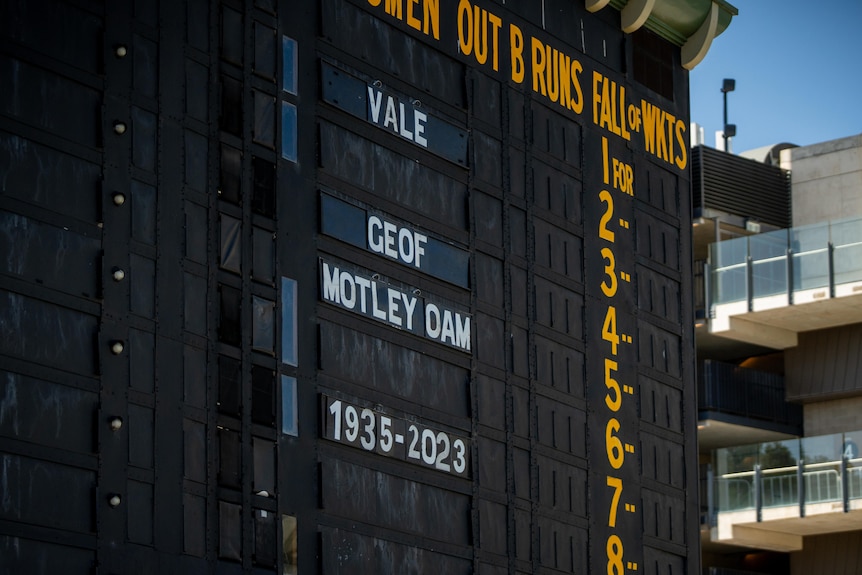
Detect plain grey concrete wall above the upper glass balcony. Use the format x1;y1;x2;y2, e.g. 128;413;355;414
781;134;862;227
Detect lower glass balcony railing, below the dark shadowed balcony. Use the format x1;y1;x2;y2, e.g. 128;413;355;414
709;431;862;518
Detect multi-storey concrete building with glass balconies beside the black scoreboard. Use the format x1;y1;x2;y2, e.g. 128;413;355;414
693;135;862;575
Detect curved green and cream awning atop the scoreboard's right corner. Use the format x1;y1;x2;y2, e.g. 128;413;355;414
584;0;739;70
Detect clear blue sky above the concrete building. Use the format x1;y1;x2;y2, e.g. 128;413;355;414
689;0;862;153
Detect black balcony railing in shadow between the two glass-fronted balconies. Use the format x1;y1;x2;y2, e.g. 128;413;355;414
697;360;802;435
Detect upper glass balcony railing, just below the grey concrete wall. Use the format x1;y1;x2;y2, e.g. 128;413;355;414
708;218;862;317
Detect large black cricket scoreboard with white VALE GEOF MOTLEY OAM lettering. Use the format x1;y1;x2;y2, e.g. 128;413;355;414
0;0;699;575
